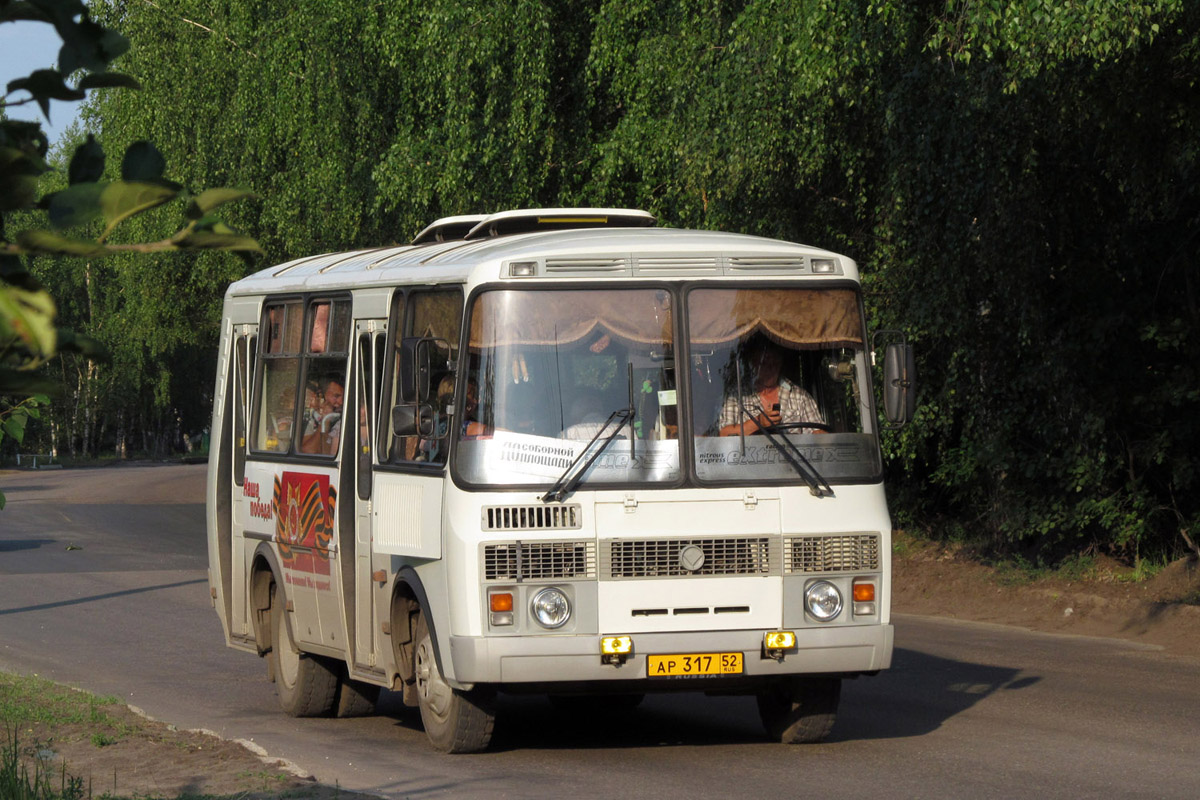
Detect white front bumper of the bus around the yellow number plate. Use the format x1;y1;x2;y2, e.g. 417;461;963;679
443;625;893;685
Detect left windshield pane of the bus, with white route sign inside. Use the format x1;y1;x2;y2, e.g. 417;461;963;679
457;289;680;486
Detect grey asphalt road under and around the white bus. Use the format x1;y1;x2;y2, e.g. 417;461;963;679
0;465;1200;799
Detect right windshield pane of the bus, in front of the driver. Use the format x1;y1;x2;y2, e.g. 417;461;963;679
688;288;881;482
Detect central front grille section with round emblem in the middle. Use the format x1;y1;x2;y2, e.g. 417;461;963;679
604;536;772;578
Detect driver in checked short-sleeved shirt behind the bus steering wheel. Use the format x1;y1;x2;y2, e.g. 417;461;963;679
718;339;824;437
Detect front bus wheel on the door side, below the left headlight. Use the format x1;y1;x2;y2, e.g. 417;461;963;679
413;613;496;753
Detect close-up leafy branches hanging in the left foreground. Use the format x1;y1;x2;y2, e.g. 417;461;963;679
0;0;258;506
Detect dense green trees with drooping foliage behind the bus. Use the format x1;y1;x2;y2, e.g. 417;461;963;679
9;0;1200;558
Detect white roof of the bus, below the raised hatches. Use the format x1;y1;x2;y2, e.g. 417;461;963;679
228;210;858;295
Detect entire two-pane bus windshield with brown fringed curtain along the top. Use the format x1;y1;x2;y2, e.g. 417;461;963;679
456;285;881;488
